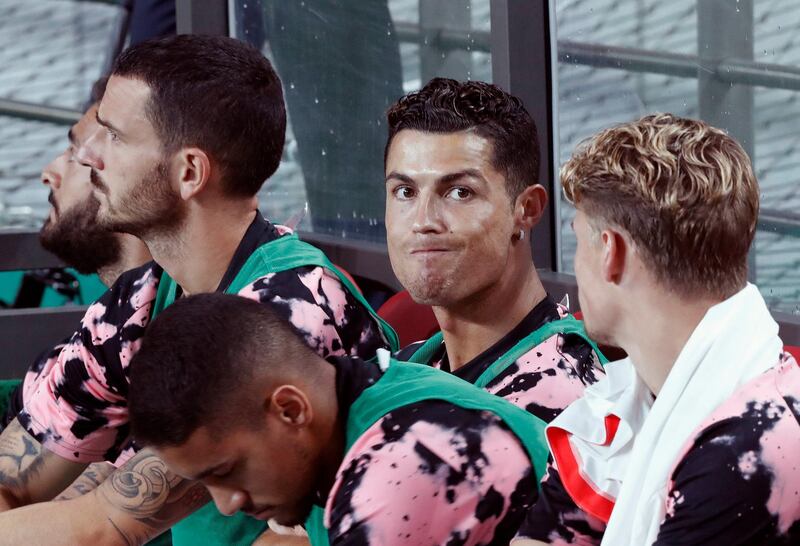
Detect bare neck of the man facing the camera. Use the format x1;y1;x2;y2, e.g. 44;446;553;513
433;261;547;371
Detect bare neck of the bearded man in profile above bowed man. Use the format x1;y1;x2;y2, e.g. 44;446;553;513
145;200;257;295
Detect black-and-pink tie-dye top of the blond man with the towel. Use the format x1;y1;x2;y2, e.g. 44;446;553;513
519;354;800;546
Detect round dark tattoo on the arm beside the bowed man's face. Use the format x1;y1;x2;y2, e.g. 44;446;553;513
97;450;210;544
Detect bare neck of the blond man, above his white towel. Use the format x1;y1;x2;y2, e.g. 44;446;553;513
618;287;720;396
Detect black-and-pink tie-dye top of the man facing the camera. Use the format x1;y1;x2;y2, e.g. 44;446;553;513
397;296;603;423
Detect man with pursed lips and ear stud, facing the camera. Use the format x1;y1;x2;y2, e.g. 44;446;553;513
385;78;602;422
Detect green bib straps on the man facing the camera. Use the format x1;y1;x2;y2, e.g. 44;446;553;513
409;315;608;387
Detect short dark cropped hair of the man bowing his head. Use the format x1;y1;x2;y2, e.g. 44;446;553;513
128;293;318;446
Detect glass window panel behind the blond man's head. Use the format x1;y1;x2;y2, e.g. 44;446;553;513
554;0;800;313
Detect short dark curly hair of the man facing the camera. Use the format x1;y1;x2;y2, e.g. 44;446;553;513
383;78;539;198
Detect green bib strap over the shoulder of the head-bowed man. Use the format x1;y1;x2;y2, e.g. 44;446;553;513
306;360;548;546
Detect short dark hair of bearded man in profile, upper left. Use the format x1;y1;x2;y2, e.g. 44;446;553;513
112;34;286;197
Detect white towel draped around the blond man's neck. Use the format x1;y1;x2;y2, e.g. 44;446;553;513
550;284;782;546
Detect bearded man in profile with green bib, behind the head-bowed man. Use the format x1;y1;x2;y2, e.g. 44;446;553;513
0;35;396;544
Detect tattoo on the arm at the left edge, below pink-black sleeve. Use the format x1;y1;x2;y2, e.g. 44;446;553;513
0;419;55;501
